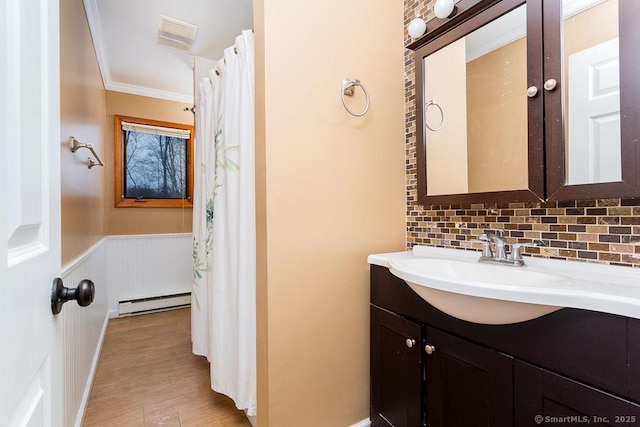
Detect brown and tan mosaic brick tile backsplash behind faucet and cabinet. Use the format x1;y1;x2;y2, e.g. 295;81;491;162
404;0;640;268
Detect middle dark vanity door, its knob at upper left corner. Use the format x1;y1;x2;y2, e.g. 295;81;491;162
423;327;519;427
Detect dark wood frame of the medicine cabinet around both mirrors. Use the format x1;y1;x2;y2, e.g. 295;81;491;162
407;0;640;205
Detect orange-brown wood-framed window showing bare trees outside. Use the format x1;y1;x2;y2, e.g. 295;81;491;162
114;116;193;208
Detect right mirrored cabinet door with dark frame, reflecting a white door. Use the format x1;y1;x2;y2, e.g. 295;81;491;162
544;0;640;200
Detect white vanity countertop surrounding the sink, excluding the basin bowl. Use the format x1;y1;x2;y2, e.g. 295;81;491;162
367;246;640;319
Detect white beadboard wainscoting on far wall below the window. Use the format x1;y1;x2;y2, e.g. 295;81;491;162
107;233;193;317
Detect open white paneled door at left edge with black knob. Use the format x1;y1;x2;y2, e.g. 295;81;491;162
0;0;62;427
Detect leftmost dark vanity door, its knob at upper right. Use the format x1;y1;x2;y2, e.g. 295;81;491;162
371;306;424;427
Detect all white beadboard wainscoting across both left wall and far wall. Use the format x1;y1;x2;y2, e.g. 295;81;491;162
61;234;192;426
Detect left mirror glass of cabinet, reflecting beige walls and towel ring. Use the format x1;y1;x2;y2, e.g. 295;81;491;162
423;5;529;196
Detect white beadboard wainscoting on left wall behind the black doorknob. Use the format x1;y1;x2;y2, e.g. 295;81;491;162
57;238;109;426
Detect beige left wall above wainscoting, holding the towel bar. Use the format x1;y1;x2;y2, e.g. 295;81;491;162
60;0;105;265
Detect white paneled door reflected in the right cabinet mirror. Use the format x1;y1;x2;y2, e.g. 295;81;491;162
567;38;622;184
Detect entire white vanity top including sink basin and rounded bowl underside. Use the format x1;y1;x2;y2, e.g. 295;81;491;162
368;246;640;324
